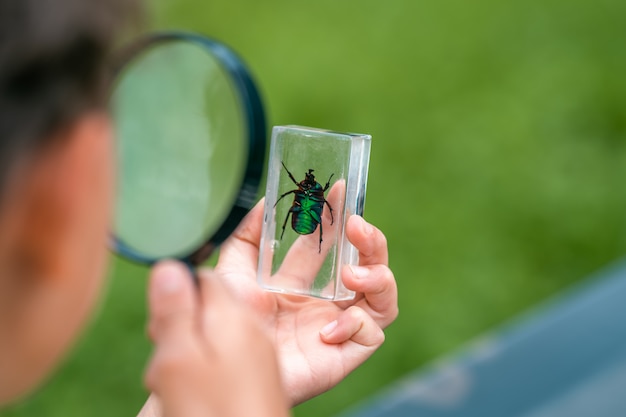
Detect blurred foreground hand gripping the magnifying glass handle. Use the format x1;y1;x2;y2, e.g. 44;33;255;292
142;261;289;417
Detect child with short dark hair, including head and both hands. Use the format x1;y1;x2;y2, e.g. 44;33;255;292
0;0;397;416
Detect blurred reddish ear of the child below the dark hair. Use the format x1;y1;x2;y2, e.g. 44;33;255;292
3;112;110;281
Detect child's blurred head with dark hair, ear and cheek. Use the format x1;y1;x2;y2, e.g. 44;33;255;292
0;0;136;404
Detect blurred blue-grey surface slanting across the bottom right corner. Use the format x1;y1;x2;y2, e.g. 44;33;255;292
342;263;626;417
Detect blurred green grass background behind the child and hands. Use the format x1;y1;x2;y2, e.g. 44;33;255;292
0;0;626;417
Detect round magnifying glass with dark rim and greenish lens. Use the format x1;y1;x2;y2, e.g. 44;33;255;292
111;32;266;266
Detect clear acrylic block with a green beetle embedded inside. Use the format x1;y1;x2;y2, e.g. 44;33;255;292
258;126;371;301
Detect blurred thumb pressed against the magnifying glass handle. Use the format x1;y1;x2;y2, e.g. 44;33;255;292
148;261;199;345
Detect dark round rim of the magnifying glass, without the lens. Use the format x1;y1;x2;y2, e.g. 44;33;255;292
111;32;267;266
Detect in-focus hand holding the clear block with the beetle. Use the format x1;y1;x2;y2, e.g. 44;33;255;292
215;201;398;405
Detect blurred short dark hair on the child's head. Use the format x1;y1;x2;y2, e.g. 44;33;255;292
0;0;139;189
